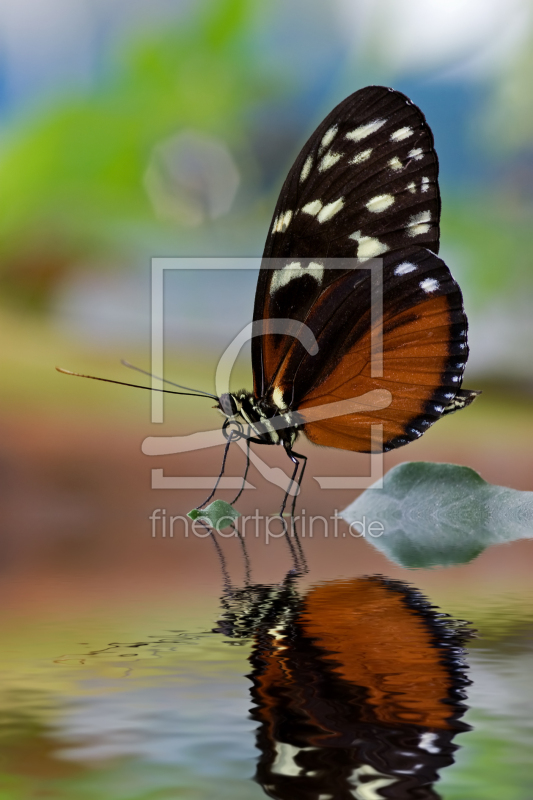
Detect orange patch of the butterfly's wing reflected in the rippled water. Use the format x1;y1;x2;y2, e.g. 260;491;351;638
301;578;452;728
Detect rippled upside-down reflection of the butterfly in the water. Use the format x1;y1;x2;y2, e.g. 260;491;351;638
216;575;471;800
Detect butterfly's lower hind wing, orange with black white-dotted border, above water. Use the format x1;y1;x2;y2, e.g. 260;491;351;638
294;249;468;452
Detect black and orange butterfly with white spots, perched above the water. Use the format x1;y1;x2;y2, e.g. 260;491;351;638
212;86;479;506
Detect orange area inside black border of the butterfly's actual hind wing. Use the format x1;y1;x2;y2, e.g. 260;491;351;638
299;296;466;452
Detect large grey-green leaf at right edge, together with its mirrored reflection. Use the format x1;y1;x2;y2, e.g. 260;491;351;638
342;462;533;568
